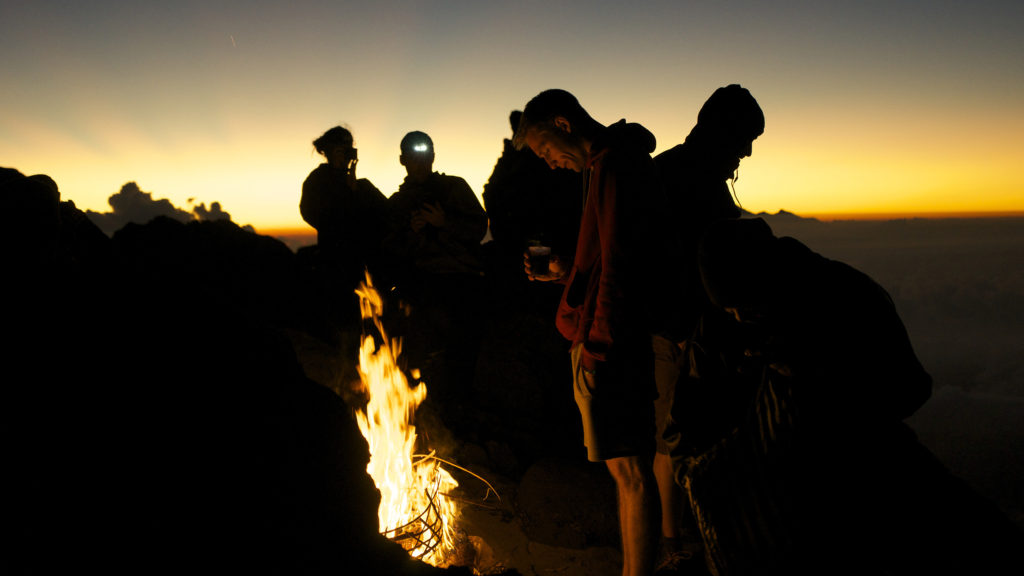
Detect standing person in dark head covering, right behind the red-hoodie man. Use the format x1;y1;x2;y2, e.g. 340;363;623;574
653;84;765;570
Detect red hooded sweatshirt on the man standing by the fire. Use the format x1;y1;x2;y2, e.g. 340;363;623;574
556;120;667;370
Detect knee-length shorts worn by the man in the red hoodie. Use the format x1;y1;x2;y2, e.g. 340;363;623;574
570;340;657;462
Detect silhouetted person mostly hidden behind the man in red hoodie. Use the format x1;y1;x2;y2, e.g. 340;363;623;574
482;110;583;315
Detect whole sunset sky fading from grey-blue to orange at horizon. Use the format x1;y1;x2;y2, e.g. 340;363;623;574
0;0;1024;231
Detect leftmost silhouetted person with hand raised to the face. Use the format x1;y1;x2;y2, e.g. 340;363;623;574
299;126;387;297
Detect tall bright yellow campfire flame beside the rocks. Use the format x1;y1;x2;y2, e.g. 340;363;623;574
355;274;458;566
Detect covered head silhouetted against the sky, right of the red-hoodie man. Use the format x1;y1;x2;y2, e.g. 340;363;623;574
686;84;765;178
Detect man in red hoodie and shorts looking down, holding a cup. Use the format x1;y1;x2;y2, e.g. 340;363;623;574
513;90;666;575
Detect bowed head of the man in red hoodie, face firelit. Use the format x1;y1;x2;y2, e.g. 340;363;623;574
512;89;603;172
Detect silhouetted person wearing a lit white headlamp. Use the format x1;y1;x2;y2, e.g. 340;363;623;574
384;131;487;423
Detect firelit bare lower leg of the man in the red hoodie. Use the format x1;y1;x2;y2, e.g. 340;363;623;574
605;456;659;576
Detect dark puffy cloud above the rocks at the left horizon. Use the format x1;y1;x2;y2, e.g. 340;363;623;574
86;181;231;236
